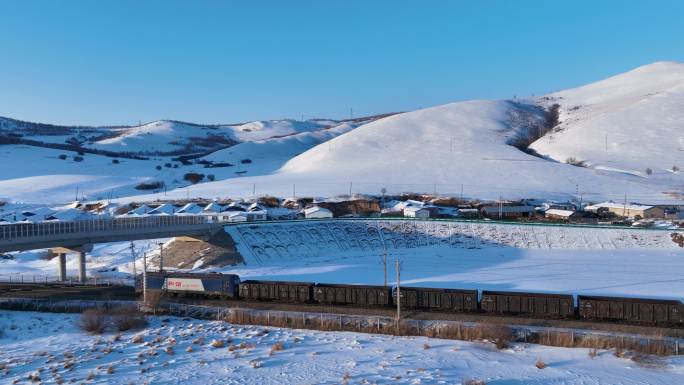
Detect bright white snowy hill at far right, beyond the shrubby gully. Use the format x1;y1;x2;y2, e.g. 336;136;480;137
531;62;684;182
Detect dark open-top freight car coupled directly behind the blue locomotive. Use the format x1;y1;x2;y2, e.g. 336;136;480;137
240;280;314;303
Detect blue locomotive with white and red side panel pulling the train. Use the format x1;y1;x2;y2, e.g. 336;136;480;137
145;271;240;298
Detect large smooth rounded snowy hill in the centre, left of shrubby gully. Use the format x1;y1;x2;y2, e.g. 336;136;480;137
121;97;670;202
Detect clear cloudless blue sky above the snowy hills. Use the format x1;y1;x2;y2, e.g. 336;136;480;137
0;0;684;124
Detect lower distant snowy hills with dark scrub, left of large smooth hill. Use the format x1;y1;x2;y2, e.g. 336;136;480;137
0;120;360;204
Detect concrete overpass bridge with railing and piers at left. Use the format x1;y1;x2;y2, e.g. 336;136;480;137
0;215;226;281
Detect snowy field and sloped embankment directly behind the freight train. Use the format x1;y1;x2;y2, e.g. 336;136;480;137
223;221;684;299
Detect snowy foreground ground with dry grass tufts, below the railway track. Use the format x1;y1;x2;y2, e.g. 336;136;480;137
0;311;684;385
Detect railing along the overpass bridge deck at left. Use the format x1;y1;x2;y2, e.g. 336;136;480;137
0;215;213;241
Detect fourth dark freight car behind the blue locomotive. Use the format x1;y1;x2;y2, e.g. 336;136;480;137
481;291;575;318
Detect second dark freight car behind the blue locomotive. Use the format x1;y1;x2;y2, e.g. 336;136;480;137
314;283;391;307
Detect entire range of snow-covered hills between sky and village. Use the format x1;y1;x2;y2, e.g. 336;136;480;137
0;63;684;204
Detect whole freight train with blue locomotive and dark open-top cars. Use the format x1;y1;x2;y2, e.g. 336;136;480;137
145;272;684;327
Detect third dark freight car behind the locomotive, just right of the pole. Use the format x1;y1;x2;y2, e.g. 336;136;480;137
394;287;478;313
